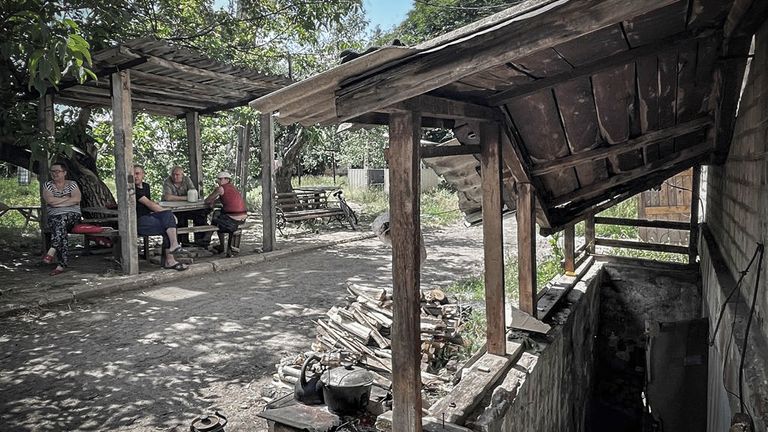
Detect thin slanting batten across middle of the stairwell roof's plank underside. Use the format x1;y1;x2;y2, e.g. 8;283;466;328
531;117;713;176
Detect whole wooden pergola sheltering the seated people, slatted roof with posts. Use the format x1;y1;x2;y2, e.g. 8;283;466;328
39;38;289;274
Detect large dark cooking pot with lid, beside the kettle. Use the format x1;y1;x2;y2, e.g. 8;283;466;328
320;364;373;414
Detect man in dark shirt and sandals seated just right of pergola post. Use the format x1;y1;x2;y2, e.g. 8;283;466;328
133;165;189;271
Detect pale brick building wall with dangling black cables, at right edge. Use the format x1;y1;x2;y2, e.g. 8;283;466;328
699;18;768;431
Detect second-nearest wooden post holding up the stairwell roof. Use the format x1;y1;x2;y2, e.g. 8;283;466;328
480;123;507;356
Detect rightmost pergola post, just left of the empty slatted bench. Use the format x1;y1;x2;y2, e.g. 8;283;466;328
259;112;276;252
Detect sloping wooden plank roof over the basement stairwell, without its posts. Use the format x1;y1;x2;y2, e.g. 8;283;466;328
251;0;760;233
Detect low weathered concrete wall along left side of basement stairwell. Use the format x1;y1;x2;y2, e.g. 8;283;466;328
467;265;603;432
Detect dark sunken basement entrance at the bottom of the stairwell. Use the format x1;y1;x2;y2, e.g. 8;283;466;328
587;264;708;432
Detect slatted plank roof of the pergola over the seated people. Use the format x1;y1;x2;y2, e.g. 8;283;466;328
52;38;290;117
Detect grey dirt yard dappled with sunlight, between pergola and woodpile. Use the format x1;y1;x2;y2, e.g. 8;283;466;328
0;219;546;431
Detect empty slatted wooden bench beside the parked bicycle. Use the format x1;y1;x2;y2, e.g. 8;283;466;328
275;190;356;234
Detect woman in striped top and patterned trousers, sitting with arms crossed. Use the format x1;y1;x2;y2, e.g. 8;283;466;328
43;163;81;276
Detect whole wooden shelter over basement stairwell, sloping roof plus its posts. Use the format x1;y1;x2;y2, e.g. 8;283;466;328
251;0;760;431
